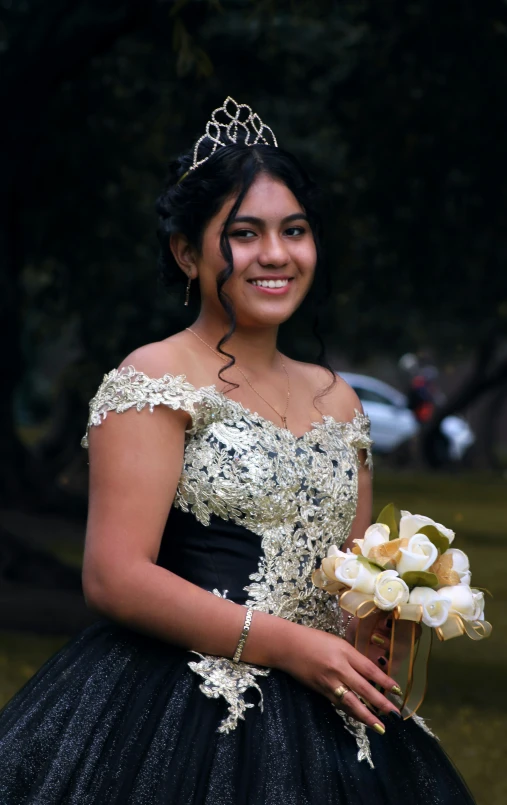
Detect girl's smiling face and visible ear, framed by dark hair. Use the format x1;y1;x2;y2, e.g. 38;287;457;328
195;174;317;327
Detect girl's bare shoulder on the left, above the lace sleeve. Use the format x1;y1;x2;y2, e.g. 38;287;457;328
118;333;196;378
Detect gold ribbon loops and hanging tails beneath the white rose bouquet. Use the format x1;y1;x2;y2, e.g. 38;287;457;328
338;589;491;719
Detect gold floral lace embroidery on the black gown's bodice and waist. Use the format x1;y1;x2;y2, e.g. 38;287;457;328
82;366;386;762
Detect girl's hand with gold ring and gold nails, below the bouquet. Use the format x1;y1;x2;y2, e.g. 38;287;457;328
276;624;401;732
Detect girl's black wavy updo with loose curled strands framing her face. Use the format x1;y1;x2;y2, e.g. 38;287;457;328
156;142;336;396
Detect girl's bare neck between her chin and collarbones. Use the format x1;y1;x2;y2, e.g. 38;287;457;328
191;315;280;371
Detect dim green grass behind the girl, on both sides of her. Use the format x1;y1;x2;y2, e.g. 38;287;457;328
0;471;507;805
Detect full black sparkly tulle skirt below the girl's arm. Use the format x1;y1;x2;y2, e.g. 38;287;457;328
0;620;473;805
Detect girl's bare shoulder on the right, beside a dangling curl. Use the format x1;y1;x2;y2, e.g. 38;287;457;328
292;361;363;421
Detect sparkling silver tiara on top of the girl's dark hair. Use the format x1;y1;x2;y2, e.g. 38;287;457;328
190;96;278;173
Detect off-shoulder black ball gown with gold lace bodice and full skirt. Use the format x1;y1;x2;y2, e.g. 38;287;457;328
0;367;473;805
